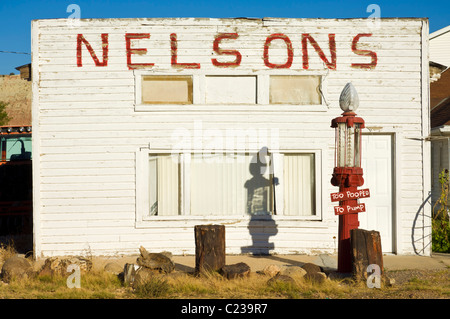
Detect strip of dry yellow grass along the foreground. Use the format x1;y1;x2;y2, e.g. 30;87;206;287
0;245;450;299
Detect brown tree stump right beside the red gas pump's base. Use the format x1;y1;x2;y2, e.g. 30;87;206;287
350;229;383;280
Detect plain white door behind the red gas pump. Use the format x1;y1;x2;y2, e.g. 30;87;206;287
358;135;394;253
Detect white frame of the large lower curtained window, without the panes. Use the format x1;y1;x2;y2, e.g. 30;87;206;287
136;148;323;228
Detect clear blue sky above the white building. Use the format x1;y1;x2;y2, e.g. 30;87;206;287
0;0;450;74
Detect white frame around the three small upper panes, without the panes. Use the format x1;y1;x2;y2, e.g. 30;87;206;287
133;70;328;112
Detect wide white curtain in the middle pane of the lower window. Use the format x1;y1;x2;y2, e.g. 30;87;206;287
190;154;272;216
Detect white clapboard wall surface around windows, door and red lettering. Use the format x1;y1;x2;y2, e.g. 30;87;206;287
32;19;430;256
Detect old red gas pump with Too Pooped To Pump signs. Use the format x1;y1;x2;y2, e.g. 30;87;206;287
331;83;370;273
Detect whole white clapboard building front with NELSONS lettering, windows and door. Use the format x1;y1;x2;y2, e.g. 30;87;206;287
32;18;430;257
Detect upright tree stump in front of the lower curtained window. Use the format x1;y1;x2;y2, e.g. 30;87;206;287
194;225;225;273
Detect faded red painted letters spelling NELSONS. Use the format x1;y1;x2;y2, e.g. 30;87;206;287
76;33;378;70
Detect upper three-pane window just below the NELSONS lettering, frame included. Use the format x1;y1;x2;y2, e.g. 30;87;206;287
133;70;327;112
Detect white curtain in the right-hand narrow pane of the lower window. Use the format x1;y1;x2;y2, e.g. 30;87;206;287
283;154;315;216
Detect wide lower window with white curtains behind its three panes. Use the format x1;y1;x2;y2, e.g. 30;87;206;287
136;150;320;220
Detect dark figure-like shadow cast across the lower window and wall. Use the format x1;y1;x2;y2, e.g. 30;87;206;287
241;148;278;255
